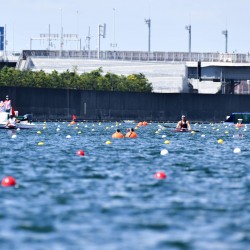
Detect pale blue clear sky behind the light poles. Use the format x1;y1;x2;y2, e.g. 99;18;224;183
0;0;250;53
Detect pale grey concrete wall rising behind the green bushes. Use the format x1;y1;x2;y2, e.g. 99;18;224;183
24;57;189;93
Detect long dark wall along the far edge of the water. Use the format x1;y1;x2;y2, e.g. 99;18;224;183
0;87;250;122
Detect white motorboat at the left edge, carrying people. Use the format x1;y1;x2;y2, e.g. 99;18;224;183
0;112;35;129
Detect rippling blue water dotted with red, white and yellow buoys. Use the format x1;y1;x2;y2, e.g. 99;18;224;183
0;123;250;250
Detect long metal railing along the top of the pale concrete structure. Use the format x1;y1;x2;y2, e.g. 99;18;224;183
18;50;250;63
